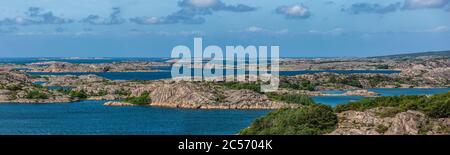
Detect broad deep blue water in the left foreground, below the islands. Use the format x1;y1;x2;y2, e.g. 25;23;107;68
0;101;269;135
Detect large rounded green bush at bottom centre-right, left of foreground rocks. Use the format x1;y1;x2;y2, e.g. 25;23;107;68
240;104;338;135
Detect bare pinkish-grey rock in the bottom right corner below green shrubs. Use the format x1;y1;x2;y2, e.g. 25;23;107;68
330;108;450;135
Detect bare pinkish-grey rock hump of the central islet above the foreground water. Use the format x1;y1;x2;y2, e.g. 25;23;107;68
126;81;296;109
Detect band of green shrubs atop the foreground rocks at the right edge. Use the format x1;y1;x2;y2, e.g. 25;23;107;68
335;92;450;118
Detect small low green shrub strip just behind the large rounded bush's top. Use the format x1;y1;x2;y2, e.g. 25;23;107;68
266;93;315;105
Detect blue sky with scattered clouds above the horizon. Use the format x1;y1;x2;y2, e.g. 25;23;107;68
0;0;450;57
